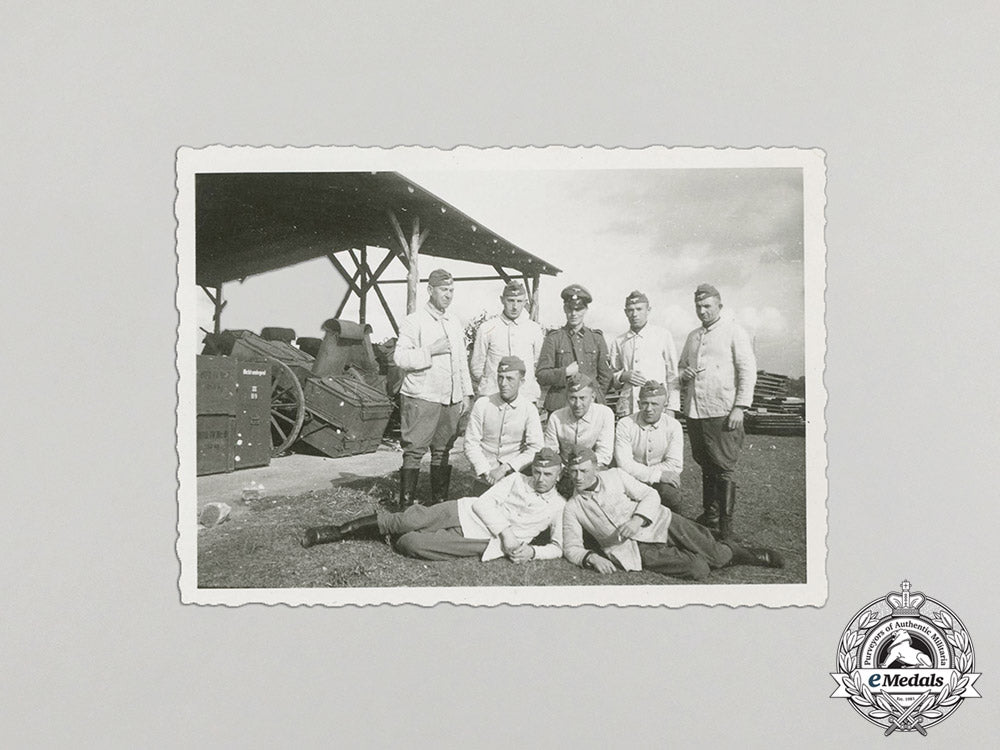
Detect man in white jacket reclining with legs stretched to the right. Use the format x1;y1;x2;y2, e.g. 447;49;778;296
563;448;784;581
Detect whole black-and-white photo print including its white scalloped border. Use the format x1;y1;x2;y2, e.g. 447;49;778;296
177;148;826;606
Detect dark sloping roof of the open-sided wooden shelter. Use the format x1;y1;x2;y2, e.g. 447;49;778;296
195;172;560;286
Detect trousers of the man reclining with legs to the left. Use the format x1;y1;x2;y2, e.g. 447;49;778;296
378;500;489;560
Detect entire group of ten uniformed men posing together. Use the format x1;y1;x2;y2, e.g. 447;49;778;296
301;269;783;580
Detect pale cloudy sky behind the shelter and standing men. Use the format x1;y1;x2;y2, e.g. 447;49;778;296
198;168;804;376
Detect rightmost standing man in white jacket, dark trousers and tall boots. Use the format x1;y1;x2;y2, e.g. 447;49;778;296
678;284;757;539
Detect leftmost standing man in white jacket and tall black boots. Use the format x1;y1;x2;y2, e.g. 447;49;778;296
393;269;472;508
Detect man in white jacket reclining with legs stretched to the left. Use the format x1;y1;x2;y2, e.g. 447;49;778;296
301;448;564;563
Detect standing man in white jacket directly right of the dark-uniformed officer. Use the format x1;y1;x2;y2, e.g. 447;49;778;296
611;291;681;417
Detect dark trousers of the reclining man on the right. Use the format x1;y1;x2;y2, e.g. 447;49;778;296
639;515;733;581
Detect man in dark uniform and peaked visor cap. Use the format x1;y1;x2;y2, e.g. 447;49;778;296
535;284;612;413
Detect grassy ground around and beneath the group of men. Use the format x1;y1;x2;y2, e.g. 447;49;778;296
198;435;806;588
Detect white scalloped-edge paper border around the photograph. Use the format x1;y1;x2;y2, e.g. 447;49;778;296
175;145;827;607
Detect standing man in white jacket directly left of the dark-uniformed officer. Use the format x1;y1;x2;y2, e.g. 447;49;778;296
469;281;544;402
